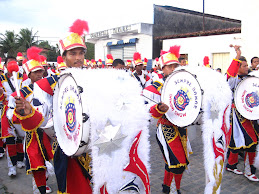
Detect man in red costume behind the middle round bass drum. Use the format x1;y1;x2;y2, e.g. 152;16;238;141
143;46;189;193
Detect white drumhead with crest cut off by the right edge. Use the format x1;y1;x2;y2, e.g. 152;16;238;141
234;77;259;120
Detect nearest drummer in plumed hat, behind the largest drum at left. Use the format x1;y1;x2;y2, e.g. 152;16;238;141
14;20;92;194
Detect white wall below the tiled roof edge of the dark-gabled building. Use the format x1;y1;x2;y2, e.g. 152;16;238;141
163;34;241;73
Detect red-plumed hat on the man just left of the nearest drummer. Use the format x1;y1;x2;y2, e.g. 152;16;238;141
23;46;44;75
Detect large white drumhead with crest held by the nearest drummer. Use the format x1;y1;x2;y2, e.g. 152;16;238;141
53;73;83;156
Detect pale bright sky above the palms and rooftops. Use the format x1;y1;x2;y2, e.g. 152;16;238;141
0;0;242;44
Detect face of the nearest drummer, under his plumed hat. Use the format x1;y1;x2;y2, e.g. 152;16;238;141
63;48;85;67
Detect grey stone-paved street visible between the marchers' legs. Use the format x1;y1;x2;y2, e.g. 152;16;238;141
0;120;259;194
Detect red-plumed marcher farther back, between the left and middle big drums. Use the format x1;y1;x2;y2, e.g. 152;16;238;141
131;52;152;89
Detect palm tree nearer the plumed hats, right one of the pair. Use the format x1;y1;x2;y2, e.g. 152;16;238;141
18;28;38;51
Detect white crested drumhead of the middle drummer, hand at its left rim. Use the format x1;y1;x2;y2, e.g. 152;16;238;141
161;70;202;127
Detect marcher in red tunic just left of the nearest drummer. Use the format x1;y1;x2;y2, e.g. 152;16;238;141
7;47;53;193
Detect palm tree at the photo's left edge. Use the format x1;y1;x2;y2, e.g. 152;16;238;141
0;31;18;57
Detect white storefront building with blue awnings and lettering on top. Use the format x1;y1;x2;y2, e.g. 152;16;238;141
86;23;153;67
